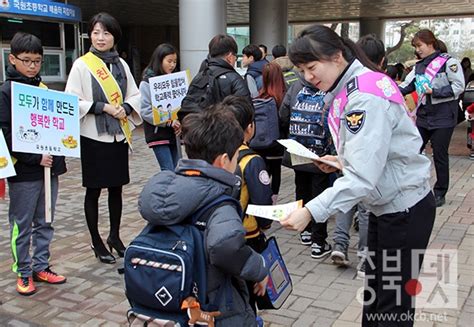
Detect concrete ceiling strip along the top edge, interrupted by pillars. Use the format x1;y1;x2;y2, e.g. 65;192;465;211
67;0;474;26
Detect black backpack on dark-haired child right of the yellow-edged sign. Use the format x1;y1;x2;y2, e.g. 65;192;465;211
178;66;229;120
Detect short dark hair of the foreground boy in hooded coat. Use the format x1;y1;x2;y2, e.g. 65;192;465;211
182;104;244;165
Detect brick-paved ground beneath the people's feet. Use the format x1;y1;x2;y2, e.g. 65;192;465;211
0;124;474;327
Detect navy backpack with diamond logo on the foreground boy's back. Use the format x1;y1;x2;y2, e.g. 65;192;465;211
124;195;242;326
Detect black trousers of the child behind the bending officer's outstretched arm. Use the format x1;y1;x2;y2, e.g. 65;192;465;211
295;170;329;245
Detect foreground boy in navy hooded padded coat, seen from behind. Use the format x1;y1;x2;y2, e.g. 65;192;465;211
138;105;268;326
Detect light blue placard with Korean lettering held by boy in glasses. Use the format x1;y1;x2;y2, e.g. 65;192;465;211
12;83;81;158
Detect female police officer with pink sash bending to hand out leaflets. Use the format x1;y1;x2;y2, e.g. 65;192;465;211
282;25;436;326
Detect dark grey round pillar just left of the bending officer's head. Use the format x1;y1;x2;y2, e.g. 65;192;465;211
249;0;288;59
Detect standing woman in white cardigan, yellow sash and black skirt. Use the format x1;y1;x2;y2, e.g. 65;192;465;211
66;13;142;263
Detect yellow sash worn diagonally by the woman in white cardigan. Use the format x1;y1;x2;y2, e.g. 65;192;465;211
81;52;133;150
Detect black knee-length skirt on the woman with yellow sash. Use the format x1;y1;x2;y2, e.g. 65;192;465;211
81;136;130;188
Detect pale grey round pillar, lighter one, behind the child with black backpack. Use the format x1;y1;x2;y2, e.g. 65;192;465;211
179;0;227;76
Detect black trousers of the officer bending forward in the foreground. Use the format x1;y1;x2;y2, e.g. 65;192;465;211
362;192;436;327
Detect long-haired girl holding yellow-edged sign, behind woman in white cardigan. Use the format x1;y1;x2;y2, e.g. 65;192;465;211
140;43;181;170
